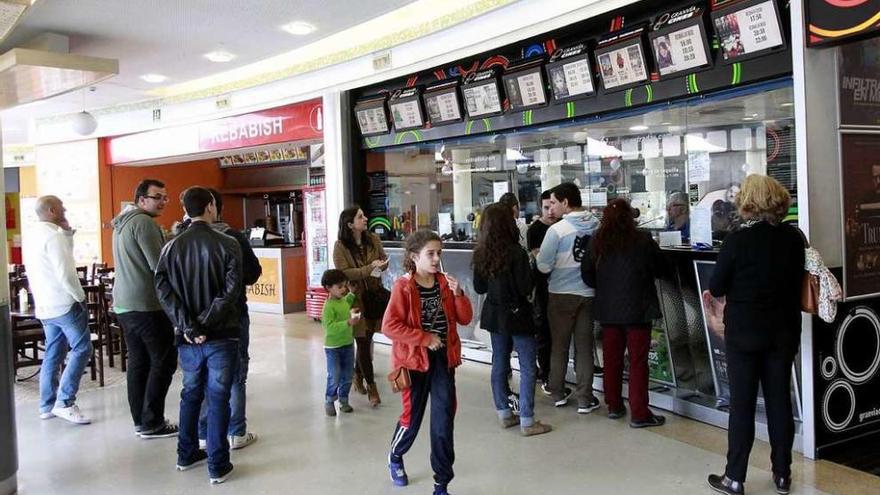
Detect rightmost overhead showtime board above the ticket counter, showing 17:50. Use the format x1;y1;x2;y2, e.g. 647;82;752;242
713;0;784;63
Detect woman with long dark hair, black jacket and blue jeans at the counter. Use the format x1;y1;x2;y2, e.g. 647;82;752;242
472;202;552;437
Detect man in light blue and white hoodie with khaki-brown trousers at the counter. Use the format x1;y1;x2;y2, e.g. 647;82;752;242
536;182;599;414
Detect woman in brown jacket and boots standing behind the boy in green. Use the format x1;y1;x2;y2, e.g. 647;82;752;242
333;205;388;407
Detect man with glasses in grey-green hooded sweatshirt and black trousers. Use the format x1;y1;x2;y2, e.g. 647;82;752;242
113;179;177;439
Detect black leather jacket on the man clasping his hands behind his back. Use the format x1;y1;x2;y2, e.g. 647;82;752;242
156;222;244;344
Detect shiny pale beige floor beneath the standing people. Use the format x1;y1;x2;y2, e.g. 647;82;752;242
10;314;880;495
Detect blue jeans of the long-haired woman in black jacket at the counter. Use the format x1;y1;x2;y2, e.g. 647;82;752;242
489;333;537;426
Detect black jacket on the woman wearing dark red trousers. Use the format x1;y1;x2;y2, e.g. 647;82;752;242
581;231;669;325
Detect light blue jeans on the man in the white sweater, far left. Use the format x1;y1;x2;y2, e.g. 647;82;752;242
40;303;92;413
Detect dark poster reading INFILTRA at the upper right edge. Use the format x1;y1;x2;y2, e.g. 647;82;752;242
837;38;880;128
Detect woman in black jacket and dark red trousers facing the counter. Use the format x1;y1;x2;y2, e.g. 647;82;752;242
581;198;666;428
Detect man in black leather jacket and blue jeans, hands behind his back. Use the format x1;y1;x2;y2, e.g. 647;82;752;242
156;187;244;484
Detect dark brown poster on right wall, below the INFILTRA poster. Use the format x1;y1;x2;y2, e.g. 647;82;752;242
840;133;880;300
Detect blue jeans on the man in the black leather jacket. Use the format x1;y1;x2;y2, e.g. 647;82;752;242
177;339;238;476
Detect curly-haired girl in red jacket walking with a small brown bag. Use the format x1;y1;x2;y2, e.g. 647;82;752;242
383;230;473;495
